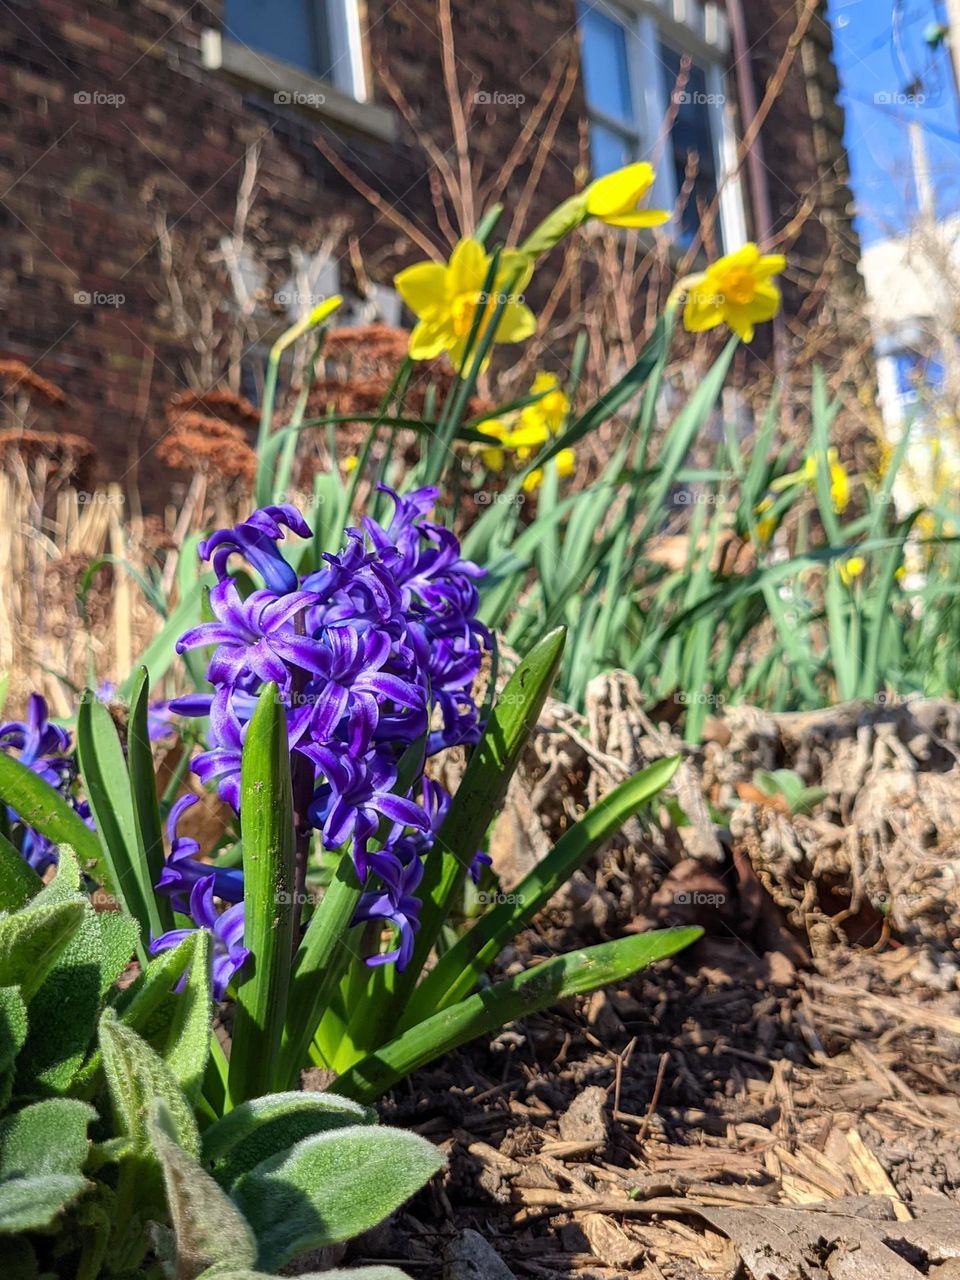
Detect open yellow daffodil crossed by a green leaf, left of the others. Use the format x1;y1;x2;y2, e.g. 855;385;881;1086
393;239;536;369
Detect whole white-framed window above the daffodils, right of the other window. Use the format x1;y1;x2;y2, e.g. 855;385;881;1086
577;0;746;250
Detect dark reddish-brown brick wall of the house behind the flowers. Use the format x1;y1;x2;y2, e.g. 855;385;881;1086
0;0;855;494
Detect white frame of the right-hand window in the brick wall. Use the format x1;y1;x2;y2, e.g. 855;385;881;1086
578;0;748;252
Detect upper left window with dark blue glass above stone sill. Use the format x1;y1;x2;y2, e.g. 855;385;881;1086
223;0;364;99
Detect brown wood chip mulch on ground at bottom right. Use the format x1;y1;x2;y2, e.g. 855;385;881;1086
335;937;960;1280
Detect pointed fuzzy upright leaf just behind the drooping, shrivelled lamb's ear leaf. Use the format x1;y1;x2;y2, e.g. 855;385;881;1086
100;1009;200;1156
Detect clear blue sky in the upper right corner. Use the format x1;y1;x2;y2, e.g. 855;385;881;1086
828;0;960;244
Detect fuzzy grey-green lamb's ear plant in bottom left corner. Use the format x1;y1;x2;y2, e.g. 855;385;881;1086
0;845;443;1280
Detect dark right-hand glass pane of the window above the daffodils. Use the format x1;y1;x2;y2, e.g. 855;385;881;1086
659;44;722;247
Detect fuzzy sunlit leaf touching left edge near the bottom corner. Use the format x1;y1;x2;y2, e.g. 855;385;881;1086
0;1098;97;1181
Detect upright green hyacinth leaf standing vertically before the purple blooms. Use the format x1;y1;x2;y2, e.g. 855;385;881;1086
229;684;298;1102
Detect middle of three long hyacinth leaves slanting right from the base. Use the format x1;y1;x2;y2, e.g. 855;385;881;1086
399;755;680;1029
